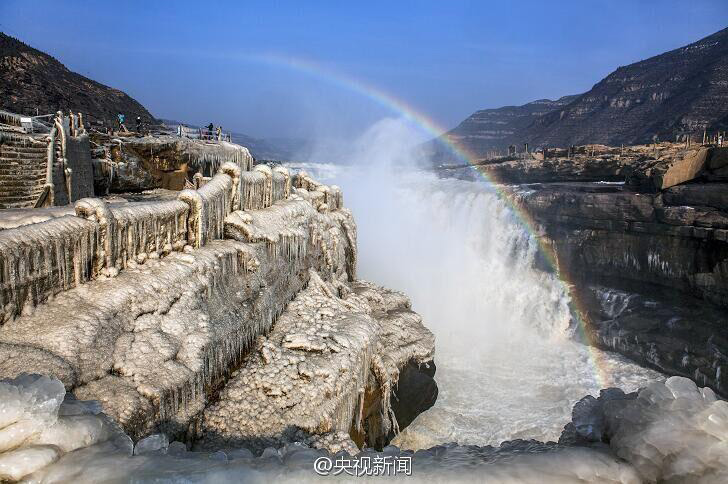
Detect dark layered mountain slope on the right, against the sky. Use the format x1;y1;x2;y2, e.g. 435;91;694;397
435;29;728;162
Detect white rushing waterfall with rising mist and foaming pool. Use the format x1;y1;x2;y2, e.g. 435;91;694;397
298;119;664;449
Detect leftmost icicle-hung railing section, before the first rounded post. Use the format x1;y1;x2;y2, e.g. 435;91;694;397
0;215;97;324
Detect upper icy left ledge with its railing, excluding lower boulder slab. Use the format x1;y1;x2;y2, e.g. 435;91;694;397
0;164;356;446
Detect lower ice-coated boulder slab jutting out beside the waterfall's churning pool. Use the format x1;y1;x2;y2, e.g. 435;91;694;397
199;272;434;452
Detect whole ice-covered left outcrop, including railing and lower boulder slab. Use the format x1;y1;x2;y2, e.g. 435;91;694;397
0;155;437;465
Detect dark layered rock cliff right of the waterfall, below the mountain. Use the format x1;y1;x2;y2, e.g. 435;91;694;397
486;143;728;395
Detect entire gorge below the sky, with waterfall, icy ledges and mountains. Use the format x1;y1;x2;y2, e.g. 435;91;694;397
0;24;728;483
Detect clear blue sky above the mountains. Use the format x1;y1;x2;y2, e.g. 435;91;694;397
0;0;728;138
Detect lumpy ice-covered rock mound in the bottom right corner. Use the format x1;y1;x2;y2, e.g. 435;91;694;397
560;376;728;483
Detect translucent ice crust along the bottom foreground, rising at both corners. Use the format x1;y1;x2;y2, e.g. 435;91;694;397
0;376;728;484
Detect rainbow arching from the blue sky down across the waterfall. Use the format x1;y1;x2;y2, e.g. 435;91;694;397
243;54;614;388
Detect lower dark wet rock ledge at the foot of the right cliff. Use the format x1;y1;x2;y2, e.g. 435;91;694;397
573;280;728;395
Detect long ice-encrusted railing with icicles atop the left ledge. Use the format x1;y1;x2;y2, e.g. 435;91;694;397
0;162;342;324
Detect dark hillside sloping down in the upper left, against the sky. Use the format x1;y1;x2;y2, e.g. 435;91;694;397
0;32;155;125
